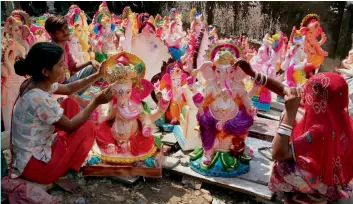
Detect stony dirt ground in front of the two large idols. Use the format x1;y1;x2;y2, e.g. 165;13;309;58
49;171;259;204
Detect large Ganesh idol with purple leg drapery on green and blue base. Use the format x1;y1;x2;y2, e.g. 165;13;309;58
190;39;256;177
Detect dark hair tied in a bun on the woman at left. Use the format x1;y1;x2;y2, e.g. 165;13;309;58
15;42;64;81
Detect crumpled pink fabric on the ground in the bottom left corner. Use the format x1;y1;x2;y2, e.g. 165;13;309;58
1;176;62;204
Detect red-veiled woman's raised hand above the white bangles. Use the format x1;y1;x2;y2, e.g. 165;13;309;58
284;88;301;122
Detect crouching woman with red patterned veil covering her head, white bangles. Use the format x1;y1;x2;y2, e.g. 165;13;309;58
268;72;353;203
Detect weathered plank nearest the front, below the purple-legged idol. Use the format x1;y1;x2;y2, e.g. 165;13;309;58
172;165;273;200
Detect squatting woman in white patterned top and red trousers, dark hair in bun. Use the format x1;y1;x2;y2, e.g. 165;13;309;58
10;42;111;192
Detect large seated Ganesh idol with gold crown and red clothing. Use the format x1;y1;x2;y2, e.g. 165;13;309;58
94;52;172;167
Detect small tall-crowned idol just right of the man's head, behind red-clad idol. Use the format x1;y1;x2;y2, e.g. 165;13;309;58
90;1;119;62
